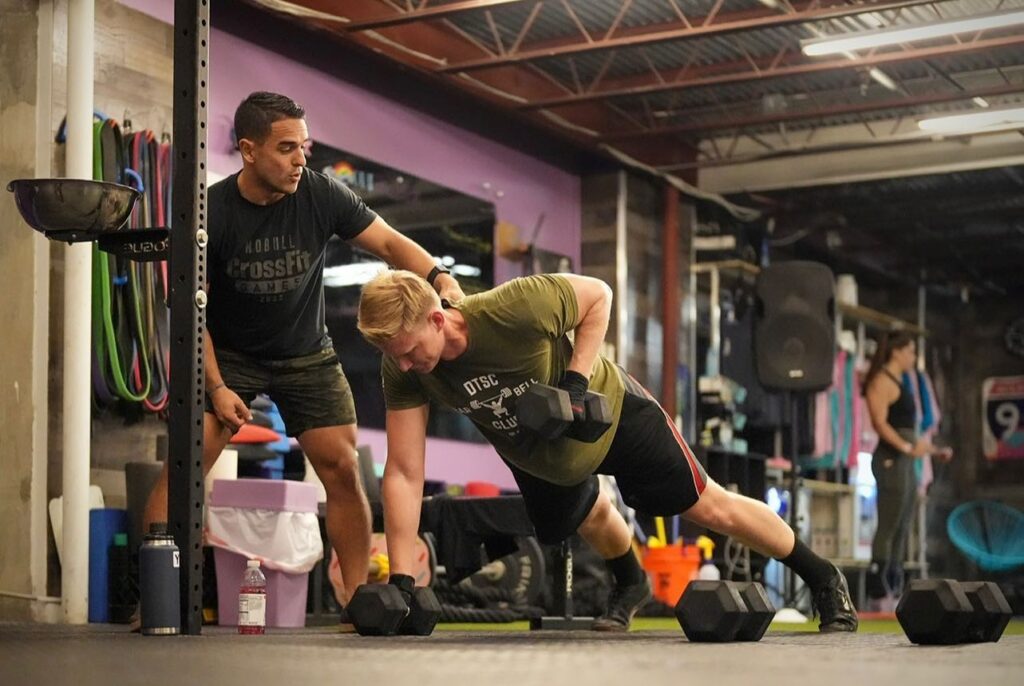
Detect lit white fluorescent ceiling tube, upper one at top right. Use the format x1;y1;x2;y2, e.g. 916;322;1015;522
801;9;1024;57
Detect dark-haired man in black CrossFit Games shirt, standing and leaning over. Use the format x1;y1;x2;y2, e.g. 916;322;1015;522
145;92;463;602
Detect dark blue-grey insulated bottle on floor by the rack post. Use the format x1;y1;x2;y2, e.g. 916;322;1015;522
138;522;181;636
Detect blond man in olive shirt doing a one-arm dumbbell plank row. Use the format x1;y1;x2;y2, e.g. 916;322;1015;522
358;271;857;632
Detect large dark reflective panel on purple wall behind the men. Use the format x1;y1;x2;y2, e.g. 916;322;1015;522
306;142;495;442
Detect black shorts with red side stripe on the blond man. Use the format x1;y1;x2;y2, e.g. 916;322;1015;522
506;370;708;544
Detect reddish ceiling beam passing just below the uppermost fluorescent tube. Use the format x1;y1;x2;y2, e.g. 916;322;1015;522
518;34;1024;110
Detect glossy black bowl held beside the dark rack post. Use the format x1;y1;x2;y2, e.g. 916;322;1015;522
7;178;142;240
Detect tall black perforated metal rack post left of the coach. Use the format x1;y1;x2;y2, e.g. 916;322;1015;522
167;0;210;635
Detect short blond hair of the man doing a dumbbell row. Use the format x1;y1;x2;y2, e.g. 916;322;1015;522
356;269;440;347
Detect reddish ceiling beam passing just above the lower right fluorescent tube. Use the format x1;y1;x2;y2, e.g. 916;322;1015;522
602;83;1024;140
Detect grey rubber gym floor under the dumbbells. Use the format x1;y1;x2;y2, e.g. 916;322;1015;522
0;618;1024;686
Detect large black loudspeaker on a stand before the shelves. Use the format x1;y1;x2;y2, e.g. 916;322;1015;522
754;261;836;391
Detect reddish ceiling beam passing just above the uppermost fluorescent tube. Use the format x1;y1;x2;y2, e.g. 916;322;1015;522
438;0;937;72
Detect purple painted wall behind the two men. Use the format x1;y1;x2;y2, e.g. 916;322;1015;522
119;0;581;487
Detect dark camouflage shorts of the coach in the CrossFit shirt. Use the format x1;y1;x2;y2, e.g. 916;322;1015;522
206;348;355;436
